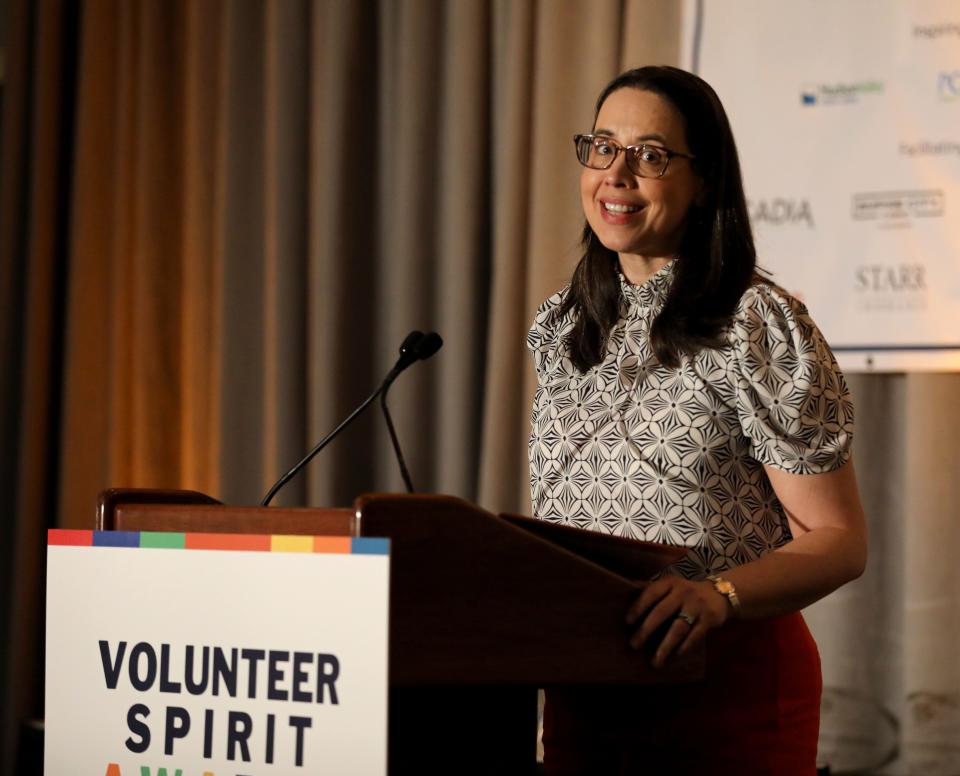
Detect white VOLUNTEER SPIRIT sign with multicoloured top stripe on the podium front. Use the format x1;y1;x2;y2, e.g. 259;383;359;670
44;530;389;776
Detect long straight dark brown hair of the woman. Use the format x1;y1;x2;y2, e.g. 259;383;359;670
557;67;756;372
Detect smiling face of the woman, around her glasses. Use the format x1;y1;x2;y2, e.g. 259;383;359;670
580;88;703;259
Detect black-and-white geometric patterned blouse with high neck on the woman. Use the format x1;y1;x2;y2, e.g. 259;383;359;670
527;263;853;579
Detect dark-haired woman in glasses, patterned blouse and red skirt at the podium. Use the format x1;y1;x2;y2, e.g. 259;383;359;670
528;67;866;776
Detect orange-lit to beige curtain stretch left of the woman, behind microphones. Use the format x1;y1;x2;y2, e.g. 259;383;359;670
60;0;679;526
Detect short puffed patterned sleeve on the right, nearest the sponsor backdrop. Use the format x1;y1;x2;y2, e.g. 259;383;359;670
731;285;853;474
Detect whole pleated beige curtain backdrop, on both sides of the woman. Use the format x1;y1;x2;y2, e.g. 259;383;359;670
0;0;960;774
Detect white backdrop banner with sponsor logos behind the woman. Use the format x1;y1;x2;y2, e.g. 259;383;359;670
684;0;960;371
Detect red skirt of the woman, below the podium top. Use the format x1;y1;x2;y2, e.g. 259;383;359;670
543;614;822;776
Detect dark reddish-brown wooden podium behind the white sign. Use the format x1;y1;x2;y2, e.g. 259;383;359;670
96;490;704;776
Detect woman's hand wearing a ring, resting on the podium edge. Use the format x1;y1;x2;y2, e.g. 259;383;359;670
627;576;730;668
